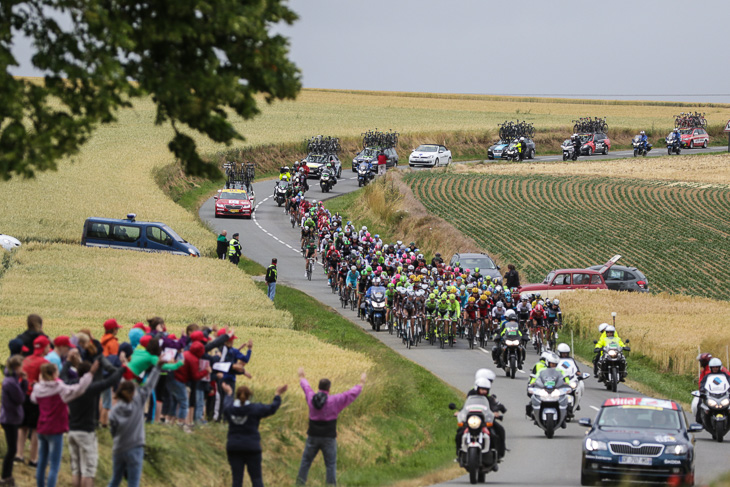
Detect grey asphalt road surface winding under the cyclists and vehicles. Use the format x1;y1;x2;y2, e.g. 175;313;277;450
199;147;730;487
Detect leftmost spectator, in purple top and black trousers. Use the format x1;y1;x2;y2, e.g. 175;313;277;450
0;355;28;486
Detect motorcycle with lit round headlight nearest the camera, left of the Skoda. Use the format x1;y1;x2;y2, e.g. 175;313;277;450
449;396;498;484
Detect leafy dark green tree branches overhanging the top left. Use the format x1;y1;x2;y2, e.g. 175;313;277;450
0;0;301;180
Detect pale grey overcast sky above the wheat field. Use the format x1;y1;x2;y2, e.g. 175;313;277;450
13;0;730;103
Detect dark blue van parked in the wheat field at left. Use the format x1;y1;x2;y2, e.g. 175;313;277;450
81;213;200;257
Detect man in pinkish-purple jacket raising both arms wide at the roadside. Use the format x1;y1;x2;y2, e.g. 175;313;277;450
297;367;367;485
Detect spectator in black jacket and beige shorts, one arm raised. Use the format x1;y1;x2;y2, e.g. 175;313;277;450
68;362;124;487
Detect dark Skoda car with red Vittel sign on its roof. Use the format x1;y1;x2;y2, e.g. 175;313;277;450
579;397;702;485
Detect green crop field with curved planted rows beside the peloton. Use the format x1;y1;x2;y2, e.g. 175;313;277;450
406;172;730;299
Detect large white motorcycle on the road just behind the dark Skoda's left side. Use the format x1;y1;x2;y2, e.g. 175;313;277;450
527;369;571;438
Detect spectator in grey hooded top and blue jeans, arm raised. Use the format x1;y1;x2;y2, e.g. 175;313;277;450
108;362;163;487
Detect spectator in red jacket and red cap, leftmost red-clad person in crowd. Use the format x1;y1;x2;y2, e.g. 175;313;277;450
16;336;51;467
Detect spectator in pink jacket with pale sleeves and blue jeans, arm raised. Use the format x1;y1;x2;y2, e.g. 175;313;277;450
30;360;99;487
